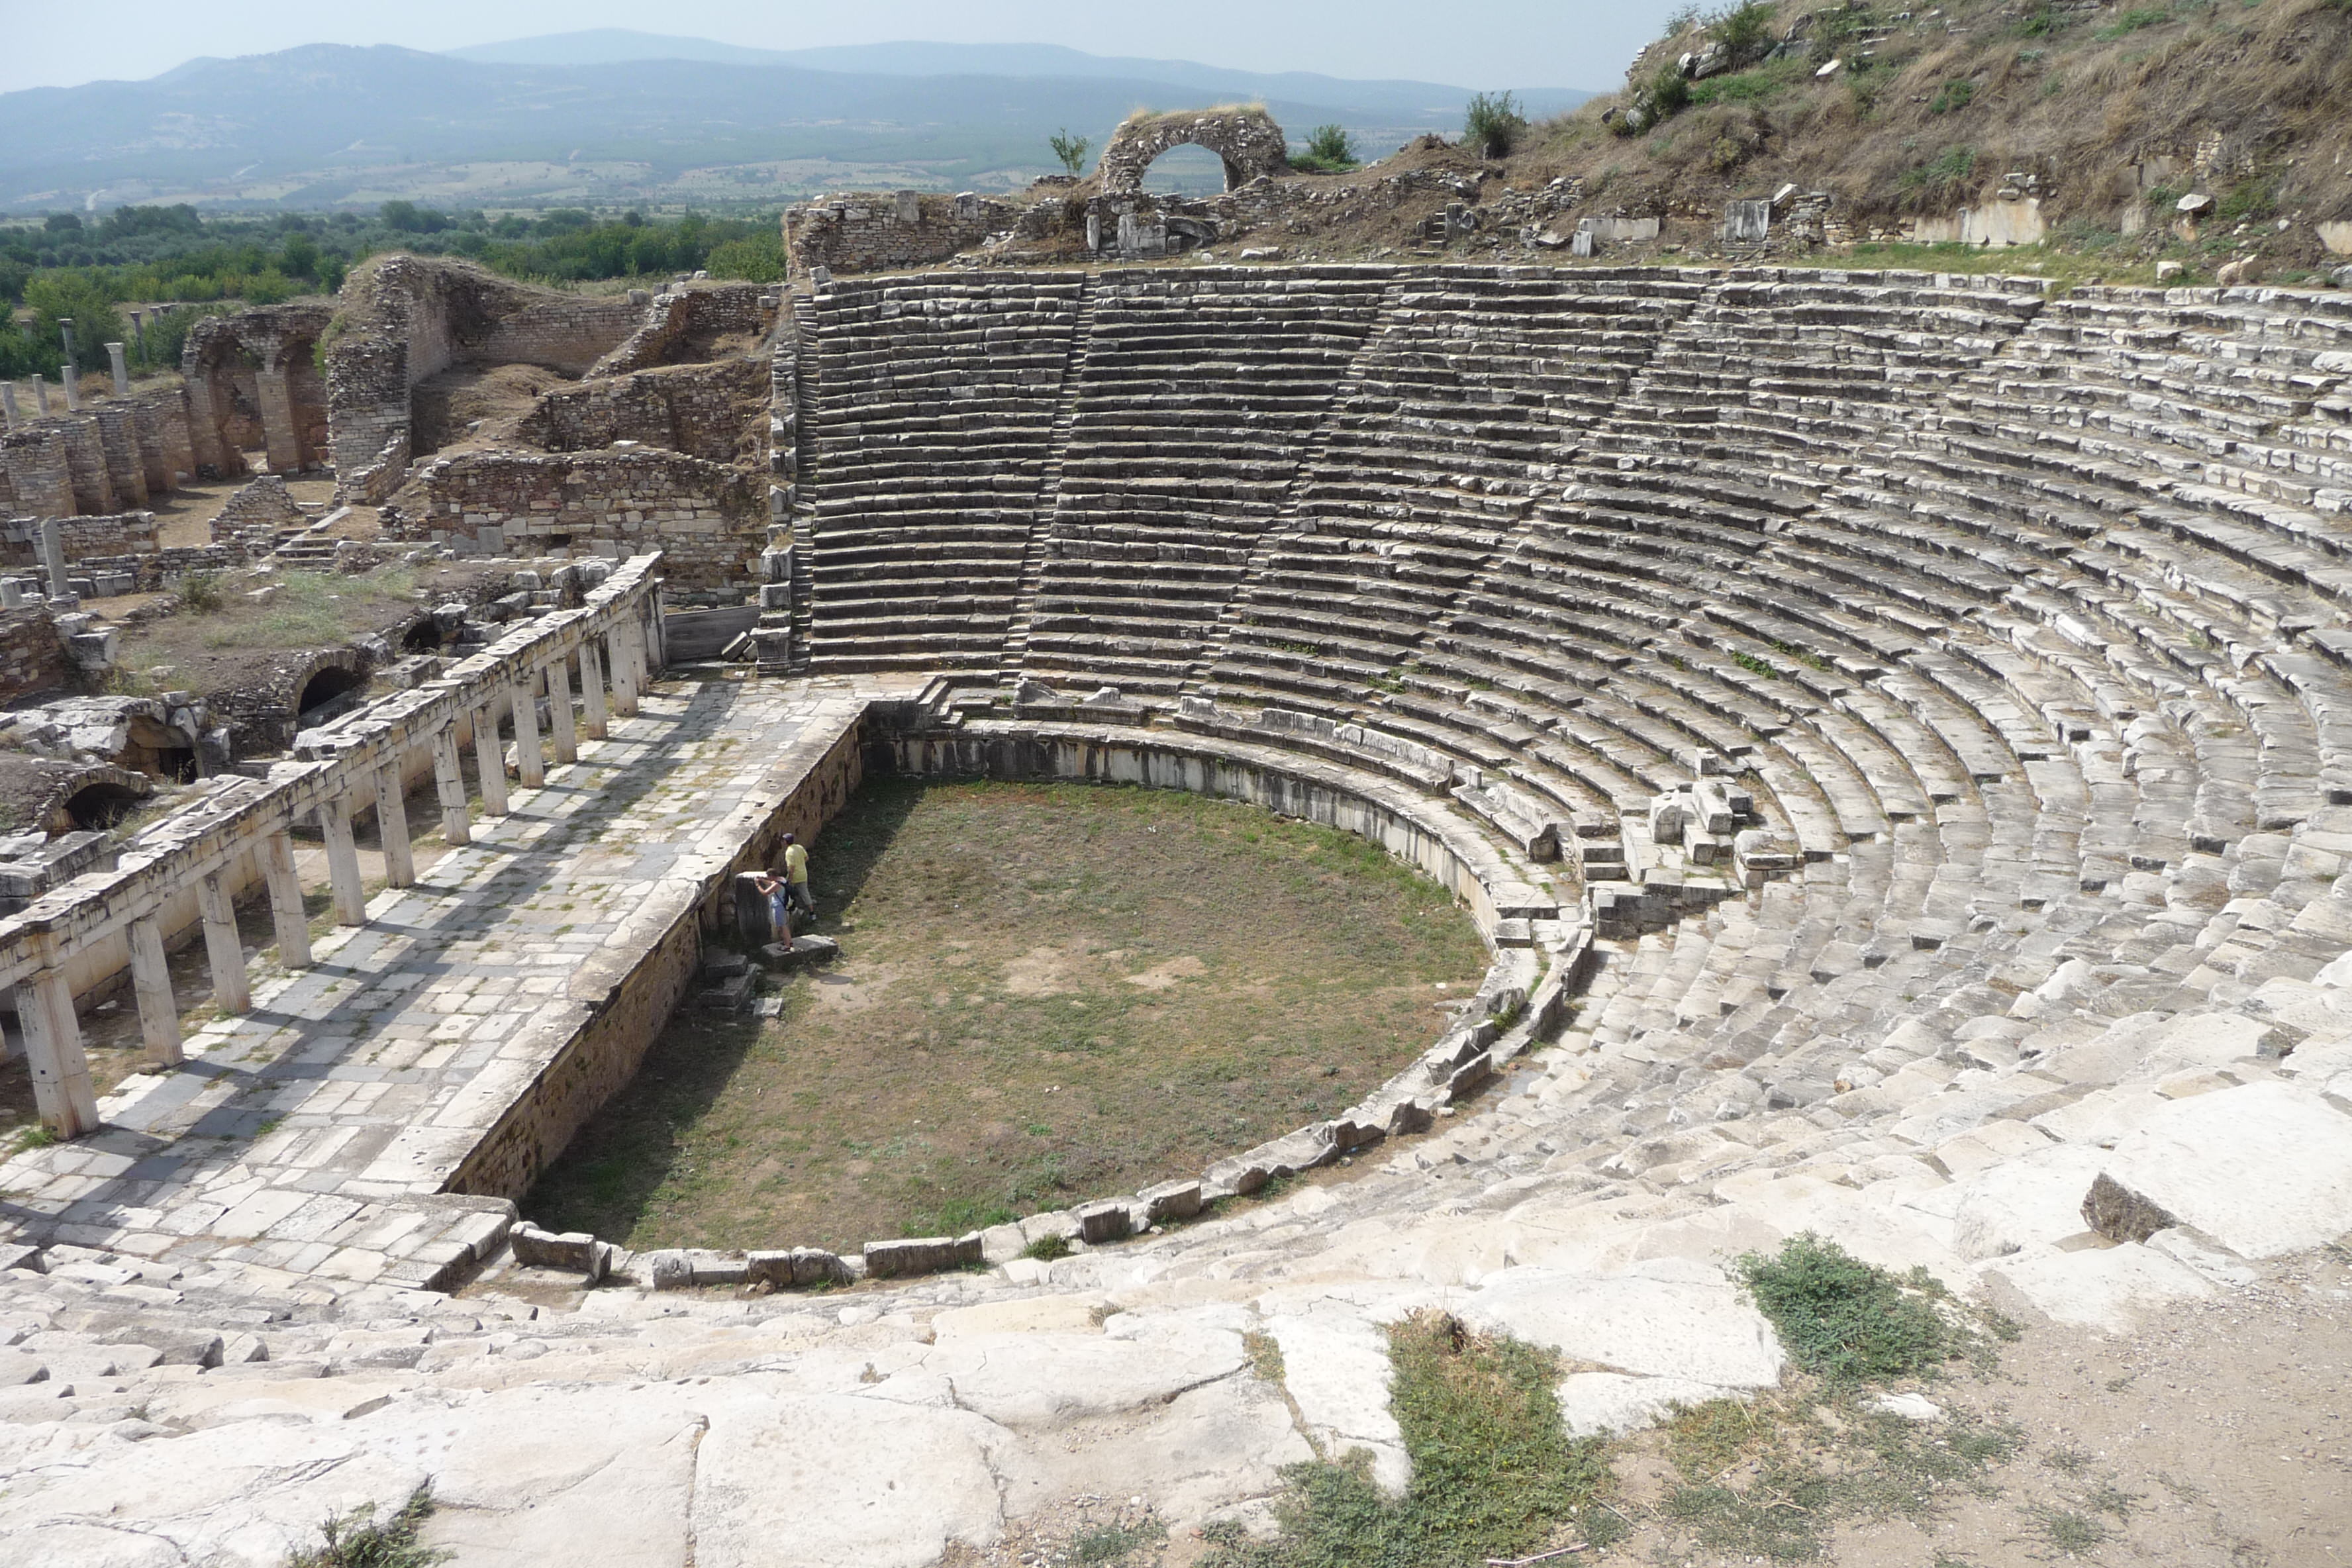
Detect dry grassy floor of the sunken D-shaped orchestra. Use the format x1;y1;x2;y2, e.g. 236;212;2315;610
524;781;1487;1248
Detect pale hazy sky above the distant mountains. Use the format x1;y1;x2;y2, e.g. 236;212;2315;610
0;0;1675;91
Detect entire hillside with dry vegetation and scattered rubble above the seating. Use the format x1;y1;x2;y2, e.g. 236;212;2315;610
1105;0;2352;285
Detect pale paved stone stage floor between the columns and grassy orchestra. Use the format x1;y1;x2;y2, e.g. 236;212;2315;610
0;679;891;1286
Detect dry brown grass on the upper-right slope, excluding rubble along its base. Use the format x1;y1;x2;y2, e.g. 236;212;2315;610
1514;0;2352;244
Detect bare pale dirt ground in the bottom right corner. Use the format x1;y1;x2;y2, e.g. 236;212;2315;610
1608;1248;2352;1568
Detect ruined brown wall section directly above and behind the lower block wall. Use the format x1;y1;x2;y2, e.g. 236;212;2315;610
517;360;771;463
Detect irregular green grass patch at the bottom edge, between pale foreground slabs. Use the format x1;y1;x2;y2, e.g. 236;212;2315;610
1204;1312;1609;1568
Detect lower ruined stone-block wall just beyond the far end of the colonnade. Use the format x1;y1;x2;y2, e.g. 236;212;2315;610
400;447;767;590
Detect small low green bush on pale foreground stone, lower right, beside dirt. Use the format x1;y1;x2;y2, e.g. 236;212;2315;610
1738;1232;1983;1385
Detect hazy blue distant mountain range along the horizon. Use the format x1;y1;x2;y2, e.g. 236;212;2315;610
0;28;1590;212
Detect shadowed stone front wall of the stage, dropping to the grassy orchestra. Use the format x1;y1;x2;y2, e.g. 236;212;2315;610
447;719;865;1199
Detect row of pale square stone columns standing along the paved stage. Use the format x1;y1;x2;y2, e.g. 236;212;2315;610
17;616;661;1138
